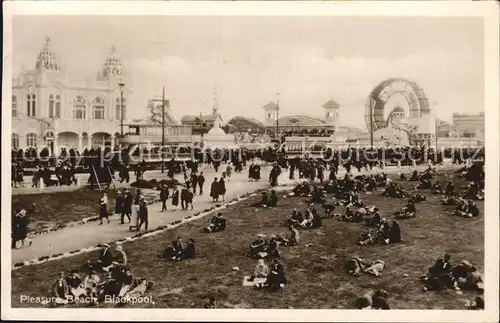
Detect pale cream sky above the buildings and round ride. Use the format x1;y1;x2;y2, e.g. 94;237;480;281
13;16;484;128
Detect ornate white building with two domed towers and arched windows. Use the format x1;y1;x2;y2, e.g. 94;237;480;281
12;37;134;154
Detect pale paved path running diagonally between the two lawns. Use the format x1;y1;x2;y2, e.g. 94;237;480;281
12;166;450;264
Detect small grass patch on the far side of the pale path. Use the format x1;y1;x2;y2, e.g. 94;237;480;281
12;189;116;232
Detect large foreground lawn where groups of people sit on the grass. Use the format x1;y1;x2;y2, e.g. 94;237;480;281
12;168;484;309
